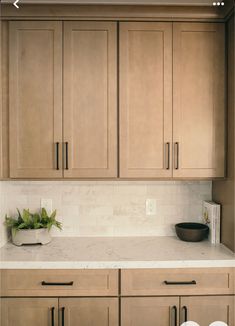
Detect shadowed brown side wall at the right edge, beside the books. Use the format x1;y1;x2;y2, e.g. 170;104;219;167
213;16;235;251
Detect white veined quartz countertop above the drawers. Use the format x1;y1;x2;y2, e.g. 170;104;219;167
0;237;235;269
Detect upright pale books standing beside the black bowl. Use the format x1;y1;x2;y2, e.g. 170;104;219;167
203;201;220;244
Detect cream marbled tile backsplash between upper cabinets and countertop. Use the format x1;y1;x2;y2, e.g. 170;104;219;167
0;181;212;244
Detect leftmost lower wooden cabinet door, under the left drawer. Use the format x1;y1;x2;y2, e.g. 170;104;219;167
0;298;58;326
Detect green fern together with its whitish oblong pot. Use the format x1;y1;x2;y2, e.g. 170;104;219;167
5;208;62;246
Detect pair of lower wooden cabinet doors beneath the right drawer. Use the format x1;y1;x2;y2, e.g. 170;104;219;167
121;295;235;326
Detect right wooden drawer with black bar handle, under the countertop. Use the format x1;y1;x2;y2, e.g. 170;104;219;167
121;268;234;295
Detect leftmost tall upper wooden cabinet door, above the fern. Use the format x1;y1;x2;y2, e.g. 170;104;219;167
9;21;62;178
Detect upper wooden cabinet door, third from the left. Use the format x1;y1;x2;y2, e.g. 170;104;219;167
120;22;172;178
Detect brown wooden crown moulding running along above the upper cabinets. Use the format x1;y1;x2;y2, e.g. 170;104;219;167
2;4;232;21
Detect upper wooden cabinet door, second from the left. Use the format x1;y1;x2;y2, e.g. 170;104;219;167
64;22;117;178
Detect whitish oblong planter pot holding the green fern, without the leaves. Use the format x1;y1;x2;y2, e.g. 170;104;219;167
11;229;51;246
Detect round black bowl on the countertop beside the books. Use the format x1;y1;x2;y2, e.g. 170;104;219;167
175;222;209;242
